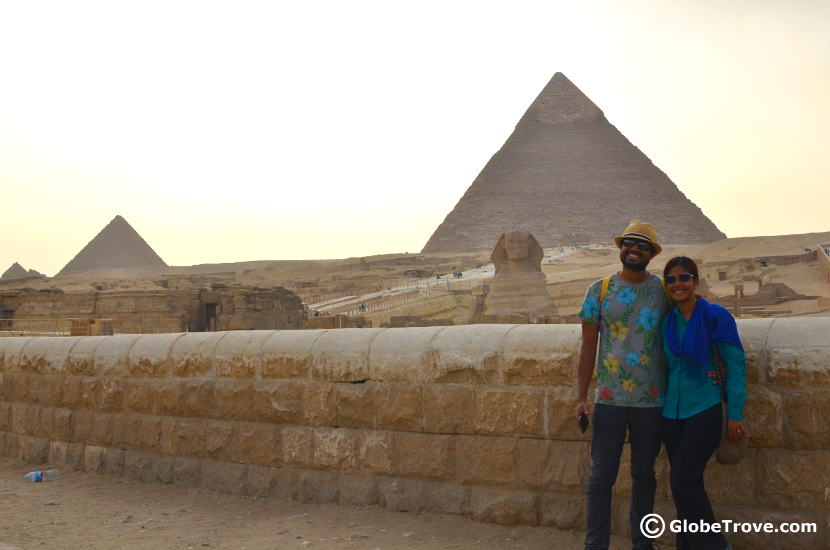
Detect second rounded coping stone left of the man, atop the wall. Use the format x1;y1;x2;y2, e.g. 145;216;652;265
426;325;515;384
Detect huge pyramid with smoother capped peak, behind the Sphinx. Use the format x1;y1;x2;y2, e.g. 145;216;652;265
423;73;726;252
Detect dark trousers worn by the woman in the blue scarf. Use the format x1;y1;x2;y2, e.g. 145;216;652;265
663;404;727;550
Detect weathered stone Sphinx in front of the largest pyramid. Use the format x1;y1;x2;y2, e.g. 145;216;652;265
484;231;556;319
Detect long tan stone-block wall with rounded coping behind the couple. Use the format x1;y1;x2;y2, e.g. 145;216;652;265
0;318;830;549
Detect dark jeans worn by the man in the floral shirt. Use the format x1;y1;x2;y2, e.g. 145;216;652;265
585;404;662;550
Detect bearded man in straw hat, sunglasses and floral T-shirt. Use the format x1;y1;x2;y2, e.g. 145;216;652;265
575;220;667;550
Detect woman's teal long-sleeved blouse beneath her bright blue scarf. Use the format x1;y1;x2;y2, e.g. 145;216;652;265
663;307;746;420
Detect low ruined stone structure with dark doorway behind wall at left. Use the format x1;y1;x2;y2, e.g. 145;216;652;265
0;285;306;333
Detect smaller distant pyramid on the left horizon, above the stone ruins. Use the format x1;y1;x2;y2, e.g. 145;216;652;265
58;216;167;275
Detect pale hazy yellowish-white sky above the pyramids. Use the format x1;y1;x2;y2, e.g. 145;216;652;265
0;0;830;275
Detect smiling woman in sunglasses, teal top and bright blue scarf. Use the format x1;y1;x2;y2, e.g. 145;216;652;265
663;256;746;550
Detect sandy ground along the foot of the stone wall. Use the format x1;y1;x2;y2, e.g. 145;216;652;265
0;458;630;550
